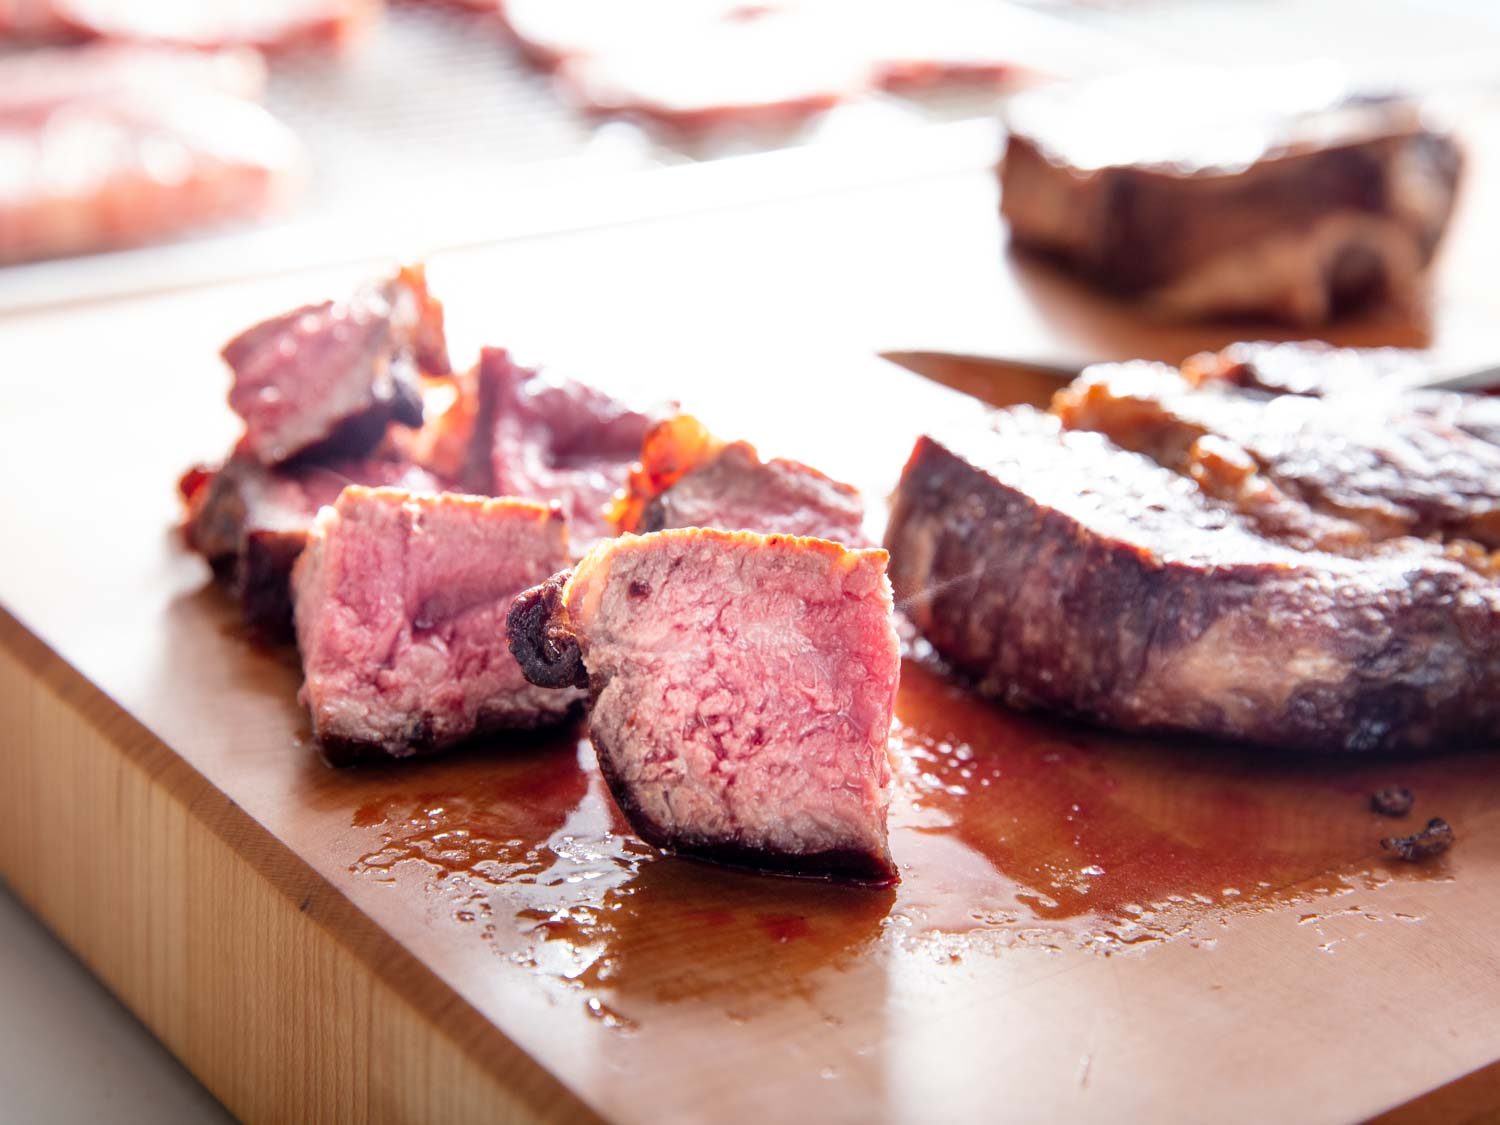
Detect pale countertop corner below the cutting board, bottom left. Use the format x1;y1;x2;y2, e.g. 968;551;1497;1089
0;882;233;1125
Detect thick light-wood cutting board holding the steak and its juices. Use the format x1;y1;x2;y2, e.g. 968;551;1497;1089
0;160;1500;1122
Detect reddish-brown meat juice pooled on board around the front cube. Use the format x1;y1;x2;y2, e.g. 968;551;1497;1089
351;660;1500;1032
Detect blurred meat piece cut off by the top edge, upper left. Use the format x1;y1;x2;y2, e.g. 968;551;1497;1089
50;0;381;51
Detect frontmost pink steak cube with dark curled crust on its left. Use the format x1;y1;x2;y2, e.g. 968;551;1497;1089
510;528;900;884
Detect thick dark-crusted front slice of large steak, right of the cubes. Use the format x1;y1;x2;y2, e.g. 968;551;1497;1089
887;410;1500;752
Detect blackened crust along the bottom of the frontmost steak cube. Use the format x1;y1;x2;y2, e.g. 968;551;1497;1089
590;729;900;887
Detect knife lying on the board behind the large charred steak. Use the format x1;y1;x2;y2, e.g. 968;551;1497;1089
881;351;1500;408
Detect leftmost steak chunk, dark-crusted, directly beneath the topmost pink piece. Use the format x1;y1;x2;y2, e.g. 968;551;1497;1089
183;458;443;639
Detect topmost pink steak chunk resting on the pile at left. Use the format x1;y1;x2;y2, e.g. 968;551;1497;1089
222;269;449;465
